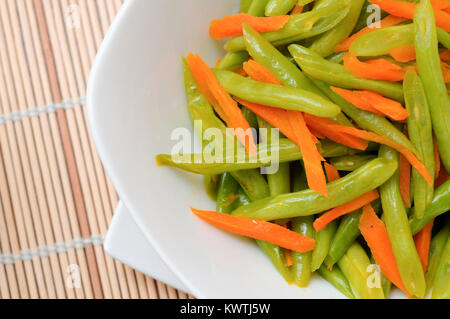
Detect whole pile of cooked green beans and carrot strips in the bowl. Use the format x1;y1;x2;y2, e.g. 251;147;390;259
156;0;450;299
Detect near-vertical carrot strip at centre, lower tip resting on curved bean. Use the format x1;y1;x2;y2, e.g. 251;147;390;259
289;111;328;197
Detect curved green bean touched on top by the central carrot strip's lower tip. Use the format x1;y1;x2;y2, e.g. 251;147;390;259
233;158;398;220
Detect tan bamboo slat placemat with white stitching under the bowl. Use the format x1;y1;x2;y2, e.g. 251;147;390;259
0;0;190;299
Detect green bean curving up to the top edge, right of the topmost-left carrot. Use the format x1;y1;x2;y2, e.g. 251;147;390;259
310;0;364;57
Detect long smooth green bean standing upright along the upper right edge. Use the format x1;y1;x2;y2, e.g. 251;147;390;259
414;0;450;172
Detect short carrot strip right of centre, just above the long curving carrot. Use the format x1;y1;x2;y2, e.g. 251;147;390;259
356;90;409;121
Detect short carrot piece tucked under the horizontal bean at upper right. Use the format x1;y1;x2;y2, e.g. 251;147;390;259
343;52;405;82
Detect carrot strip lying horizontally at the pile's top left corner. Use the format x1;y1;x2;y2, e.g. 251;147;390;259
209;13;289;39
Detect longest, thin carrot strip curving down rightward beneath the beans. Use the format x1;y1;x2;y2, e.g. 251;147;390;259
305;114;433;185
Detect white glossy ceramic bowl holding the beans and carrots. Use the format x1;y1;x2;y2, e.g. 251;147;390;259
88;0;343;298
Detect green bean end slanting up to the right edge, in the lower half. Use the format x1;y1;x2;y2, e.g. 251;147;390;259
410;180;450;235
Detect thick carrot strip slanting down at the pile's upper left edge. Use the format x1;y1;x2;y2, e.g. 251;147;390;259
187;53;256;155
